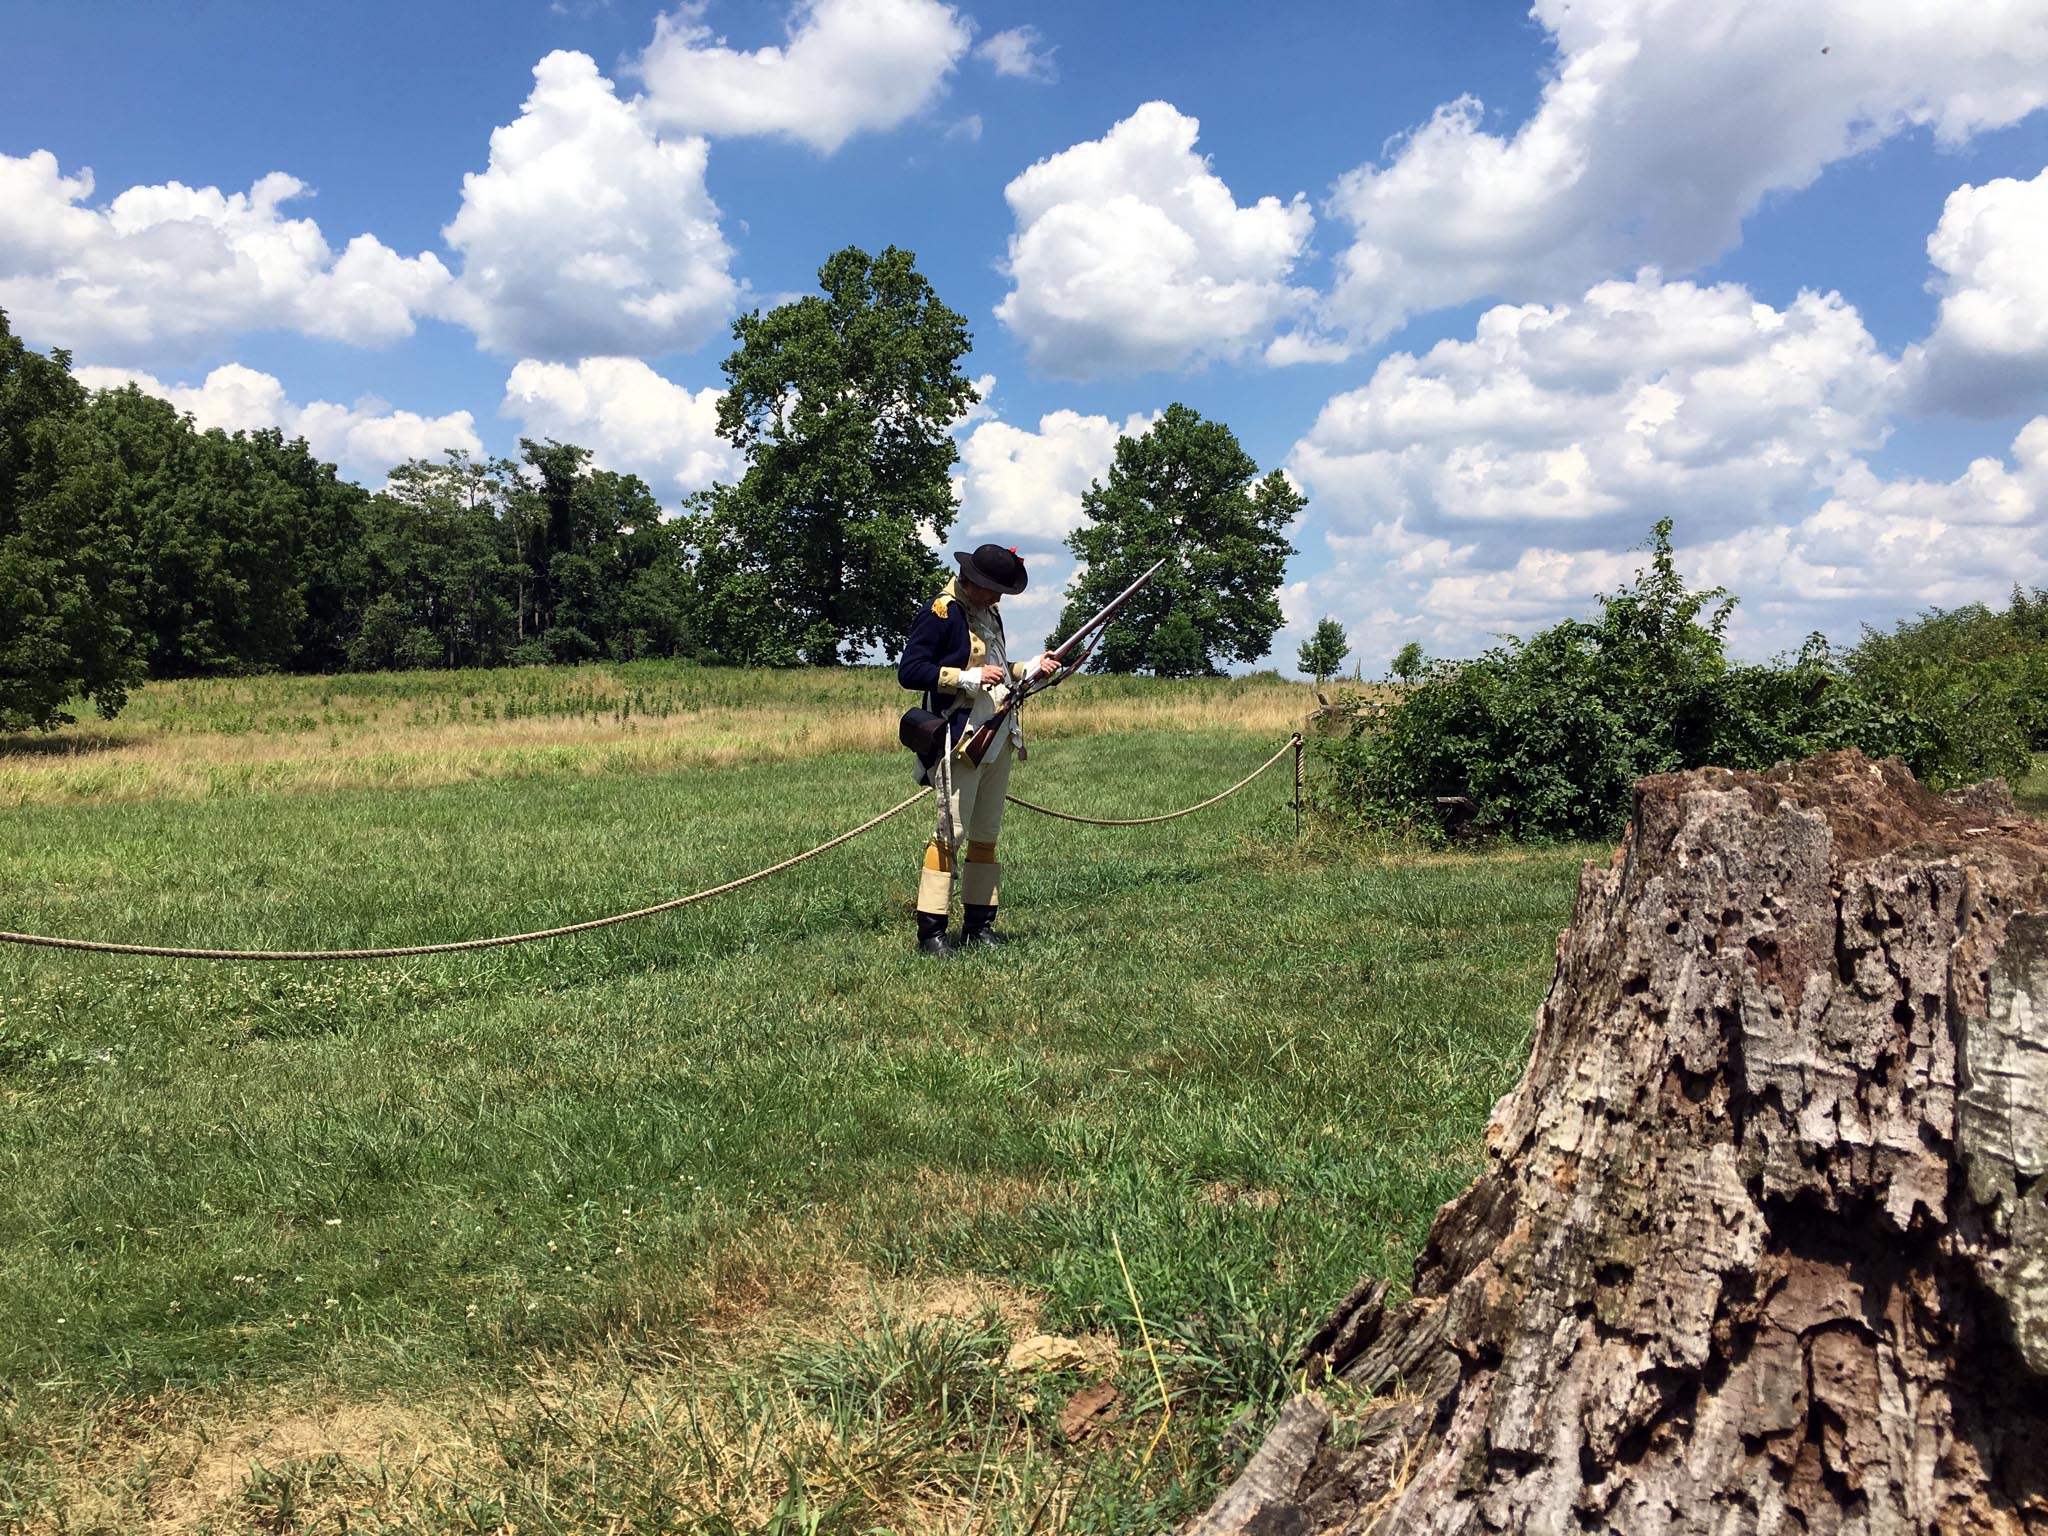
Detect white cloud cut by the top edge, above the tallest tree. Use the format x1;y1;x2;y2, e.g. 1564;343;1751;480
635;0;973;154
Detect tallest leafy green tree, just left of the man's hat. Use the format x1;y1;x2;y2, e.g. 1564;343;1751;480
688;246;977;666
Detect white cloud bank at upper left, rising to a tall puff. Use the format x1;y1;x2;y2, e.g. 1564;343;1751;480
0;51;741;358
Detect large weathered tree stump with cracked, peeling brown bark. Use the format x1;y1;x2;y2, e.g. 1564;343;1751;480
1204;754;2048;1536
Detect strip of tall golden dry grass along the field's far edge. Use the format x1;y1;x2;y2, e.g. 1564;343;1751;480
0;668;1315;807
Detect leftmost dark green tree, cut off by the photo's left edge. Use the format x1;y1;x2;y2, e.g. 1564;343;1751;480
0;311;143;731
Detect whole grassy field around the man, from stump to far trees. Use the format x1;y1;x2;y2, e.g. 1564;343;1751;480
0;672;1604;1532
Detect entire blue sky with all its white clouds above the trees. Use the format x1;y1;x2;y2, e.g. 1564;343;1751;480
0;0;2048;668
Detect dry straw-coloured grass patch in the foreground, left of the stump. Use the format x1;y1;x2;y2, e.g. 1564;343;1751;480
12;1264;1089;1536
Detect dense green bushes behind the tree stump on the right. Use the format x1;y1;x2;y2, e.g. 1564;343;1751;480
1319;520;2048;842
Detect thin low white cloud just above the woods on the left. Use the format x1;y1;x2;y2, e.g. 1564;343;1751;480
74;362;483;483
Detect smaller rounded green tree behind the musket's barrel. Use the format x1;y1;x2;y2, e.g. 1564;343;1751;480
1059;403;1307;678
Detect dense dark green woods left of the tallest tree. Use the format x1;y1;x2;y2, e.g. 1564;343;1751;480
0;296;712;704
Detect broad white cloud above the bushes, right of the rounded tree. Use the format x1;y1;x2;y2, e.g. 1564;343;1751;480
1290;272;1898;545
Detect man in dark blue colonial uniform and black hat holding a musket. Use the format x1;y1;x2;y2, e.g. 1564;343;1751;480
897;545;1059;954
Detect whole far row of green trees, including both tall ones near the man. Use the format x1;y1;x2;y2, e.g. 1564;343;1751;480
0;248;1303;729
